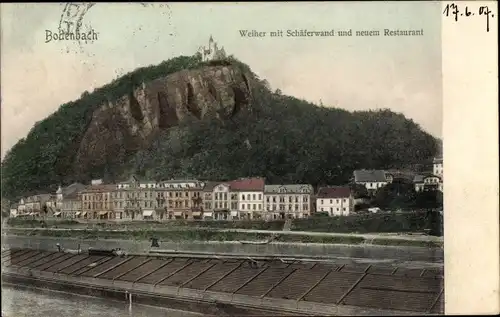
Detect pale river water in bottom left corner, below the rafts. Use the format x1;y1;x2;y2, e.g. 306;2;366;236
2;285;202;317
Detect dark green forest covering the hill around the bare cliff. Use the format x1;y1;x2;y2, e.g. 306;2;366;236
2;56;437;198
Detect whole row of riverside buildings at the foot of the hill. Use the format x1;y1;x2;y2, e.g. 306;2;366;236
11;160;443;221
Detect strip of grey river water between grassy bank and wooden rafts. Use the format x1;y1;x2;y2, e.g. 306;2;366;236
2;235;444;266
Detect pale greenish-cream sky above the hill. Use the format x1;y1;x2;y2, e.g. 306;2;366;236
0;1;443;158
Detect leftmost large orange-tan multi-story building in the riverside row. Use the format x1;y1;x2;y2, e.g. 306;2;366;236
76;182;115;219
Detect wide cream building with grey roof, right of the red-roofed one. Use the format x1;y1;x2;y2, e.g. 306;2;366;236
264;184;313;219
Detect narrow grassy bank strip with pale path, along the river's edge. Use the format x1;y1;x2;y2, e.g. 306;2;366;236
3;228;443;248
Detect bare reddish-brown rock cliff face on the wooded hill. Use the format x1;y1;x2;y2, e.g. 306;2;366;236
75;65;252;173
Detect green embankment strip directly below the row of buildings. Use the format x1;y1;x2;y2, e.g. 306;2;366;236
3;211;442;234
